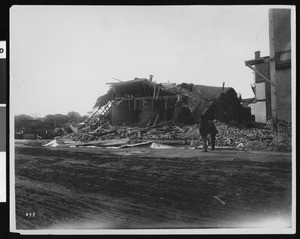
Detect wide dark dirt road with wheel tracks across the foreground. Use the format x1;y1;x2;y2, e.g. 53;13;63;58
15;145;291;229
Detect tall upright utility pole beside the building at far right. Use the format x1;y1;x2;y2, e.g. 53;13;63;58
269;9;278;145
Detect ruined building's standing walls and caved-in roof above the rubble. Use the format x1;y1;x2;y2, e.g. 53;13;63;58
94;76;251;127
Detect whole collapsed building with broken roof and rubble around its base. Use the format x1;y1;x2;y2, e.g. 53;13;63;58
44;76;290;151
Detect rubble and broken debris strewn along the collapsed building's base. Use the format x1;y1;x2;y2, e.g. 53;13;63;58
51;114;291;151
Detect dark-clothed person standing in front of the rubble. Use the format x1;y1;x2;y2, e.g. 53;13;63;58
199;109;218;152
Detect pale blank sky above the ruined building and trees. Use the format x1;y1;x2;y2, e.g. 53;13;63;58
10;6;269;117
